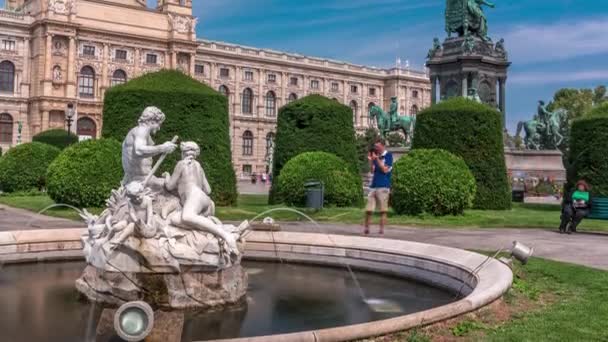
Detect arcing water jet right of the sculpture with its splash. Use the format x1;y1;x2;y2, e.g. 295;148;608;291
249;208;402;312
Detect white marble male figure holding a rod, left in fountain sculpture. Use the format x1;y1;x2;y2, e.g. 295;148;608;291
122;107;177;189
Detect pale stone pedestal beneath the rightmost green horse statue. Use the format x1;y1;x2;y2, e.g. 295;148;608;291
505;148;566;183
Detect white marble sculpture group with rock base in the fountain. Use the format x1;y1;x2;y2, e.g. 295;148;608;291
76;107;249;309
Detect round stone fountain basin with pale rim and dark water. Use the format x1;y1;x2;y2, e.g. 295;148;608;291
0;229;512;341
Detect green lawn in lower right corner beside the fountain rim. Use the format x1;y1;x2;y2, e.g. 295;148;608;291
364;258;608;342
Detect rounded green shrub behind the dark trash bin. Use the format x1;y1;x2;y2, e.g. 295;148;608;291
277;152;363;207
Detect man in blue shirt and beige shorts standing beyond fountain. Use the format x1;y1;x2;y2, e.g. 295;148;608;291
363;140;393;235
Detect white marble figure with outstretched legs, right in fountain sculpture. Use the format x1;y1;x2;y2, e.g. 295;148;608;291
164;141;239;254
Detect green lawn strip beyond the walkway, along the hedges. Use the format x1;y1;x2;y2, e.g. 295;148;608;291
0;195;608;231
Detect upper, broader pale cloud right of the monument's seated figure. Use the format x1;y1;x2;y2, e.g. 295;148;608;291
504;17;608;65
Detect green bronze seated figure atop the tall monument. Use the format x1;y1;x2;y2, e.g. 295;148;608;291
445;0;494;41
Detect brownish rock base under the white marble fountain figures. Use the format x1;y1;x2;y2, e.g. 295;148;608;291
76;264;247;310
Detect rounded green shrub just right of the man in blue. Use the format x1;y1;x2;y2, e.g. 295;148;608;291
391;149;477;216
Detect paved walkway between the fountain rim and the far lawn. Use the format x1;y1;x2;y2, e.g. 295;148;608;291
0;205;608;270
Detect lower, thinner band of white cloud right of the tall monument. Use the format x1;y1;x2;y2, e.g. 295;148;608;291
508;67;608;85
